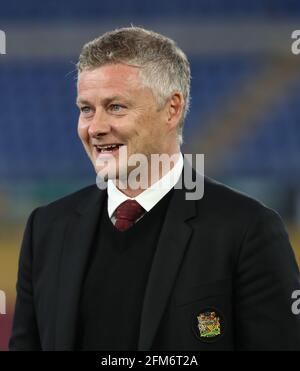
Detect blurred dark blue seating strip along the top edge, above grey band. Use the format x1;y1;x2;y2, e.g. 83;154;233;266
1;0;300;21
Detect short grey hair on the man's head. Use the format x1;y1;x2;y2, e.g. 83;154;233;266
77;27;191;144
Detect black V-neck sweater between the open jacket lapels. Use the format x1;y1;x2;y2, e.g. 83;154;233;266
76;189;173;350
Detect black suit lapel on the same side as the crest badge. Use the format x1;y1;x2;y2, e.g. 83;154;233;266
138;164;196;351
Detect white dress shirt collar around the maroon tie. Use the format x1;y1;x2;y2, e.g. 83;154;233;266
107;152;183;224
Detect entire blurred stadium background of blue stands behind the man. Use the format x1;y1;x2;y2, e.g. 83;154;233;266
0;0;300;350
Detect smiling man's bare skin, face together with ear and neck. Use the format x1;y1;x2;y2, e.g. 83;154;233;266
77;63;184;192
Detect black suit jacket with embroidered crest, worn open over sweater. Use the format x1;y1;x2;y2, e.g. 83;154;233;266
10;165;300;351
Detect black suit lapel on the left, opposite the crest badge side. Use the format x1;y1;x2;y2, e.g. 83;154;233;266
55;187;105;350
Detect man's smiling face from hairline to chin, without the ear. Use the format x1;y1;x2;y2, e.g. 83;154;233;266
77;64;167;178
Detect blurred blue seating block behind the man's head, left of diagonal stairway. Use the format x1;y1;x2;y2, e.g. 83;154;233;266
0;57;259;182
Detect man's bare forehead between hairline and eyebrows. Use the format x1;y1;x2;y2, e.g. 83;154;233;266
77;64;140;94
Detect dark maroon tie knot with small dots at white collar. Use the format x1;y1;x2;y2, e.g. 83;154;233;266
115;200;145;231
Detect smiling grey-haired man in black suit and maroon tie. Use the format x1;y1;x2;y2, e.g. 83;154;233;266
10;27;300;351
